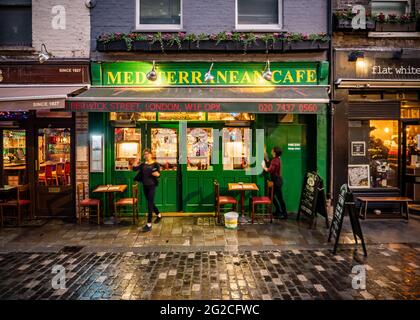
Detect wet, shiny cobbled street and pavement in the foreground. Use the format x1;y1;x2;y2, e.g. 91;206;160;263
0;212;420;300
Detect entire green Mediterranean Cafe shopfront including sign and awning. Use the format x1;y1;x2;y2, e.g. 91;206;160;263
66;61;329;213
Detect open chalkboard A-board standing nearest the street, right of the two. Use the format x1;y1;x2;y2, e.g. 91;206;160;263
328;184;367;256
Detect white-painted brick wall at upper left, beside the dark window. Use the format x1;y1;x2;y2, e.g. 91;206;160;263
32;0;90;58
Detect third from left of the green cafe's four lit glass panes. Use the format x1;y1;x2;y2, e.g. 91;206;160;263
187;128;213;170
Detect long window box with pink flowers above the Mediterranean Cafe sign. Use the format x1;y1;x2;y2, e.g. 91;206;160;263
97;32;329;53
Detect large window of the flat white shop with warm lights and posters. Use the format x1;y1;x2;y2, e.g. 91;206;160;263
348;120;399;188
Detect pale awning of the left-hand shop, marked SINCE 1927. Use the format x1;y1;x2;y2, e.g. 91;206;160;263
0;84;87;112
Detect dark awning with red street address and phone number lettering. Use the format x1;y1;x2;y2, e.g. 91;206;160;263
66;86;329;113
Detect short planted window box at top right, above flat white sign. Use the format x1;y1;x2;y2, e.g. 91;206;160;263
375;13;417;32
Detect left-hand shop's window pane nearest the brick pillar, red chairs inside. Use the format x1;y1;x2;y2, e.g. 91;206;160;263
38;128;71;185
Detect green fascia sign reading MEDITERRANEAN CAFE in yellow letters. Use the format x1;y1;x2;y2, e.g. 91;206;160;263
92;62;328;87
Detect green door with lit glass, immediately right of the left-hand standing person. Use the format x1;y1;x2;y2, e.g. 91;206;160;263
148;124;181;212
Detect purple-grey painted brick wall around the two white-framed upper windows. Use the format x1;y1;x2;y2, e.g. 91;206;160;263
91;0;328;54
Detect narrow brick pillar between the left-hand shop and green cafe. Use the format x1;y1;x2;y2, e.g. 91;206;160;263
76;112;89;219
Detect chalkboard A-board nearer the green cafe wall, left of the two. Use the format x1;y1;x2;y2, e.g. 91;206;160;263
297;172;328;228
